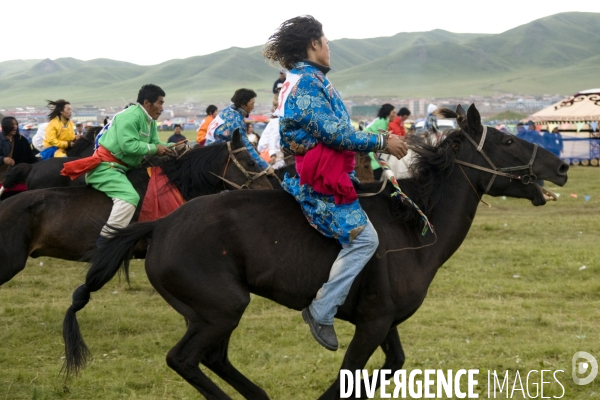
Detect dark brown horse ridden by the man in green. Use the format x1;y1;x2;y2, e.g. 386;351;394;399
0;133;273;285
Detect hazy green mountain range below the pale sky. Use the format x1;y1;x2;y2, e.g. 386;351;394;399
0;12;600;107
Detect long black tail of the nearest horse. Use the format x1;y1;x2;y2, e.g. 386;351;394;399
62;221;156;377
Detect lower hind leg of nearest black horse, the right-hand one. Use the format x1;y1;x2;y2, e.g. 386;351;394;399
202;337;269;400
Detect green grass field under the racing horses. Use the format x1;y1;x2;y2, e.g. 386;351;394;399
0;167;600;400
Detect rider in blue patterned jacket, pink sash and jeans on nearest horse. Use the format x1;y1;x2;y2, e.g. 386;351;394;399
265;16;407;350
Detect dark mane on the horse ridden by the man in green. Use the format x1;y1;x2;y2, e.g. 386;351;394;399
159;143;228;199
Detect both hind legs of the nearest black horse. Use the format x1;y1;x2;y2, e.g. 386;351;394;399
152;268;260;400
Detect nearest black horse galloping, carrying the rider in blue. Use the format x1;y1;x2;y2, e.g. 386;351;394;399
63;106;569;399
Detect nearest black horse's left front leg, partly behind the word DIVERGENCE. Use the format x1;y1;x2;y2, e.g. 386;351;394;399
319;320;391;400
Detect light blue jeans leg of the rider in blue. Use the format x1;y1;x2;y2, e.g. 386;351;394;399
309;220;379;325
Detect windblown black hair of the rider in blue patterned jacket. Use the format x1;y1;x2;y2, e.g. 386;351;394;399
263;15;323;69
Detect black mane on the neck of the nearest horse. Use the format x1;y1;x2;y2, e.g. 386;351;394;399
393;109;463;225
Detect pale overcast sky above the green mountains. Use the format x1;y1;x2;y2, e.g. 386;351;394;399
0;0;600;65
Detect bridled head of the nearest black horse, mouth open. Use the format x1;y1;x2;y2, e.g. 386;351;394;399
438;104;569;206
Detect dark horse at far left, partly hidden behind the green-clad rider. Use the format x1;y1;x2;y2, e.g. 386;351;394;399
4;126;102;190
